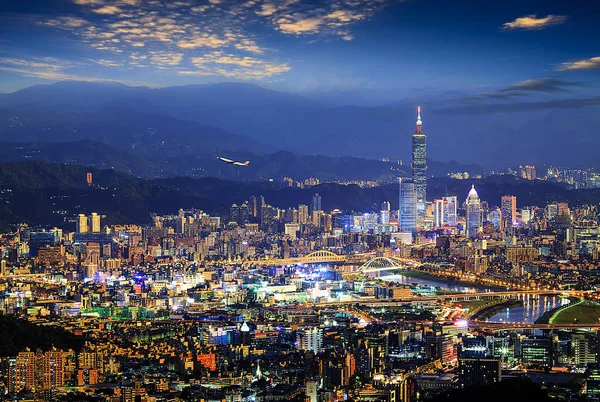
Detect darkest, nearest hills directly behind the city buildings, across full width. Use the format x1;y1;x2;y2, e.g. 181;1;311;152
0;161;600;229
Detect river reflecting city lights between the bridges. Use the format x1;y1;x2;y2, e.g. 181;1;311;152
381;274;569;323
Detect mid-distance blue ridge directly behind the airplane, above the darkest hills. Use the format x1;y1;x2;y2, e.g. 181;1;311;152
0;140;483;182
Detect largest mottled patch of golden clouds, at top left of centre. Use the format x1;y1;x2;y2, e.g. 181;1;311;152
30;0;391;79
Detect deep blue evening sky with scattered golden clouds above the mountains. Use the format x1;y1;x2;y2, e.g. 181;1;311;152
0;0;600;102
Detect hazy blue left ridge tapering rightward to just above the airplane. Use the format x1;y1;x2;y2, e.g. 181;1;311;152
0;106;269;156
